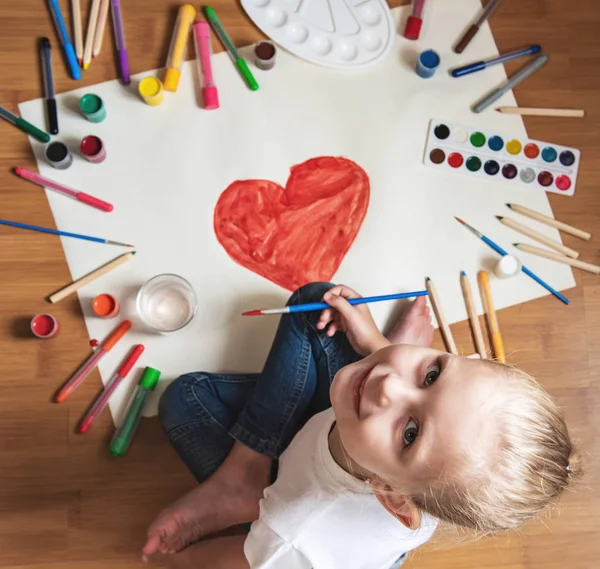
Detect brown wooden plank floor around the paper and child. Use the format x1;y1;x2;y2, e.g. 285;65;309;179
0;0;600;569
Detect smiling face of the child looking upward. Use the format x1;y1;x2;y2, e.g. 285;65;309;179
331;345;503;492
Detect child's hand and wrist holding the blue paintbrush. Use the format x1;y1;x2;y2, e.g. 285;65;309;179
317;285;389;356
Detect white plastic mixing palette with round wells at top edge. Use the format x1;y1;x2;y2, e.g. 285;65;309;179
242;0;396;68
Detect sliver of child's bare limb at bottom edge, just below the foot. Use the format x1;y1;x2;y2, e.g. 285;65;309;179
163;535;250;569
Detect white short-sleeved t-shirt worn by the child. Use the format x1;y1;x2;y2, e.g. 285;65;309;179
244;409;437;569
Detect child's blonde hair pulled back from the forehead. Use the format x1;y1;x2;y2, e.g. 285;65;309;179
410;361;582;534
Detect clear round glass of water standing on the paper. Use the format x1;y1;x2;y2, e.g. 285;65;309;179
136;274;198;334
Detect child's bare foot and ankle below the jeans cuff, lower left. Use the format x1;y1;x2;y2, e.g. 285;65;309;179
142;442;272;556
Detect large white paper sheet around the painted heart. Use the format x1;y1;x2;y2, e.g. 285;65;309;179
20;0;574;416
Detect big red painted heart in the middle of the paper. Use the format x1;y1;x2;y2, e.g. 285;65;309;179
214;156;369;291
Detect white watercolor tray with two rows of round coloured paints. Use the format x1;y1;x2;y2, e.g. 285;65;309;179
424;119;581;196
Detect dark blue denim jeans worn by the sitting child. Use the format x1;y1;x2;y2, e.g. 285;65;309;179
159;283;361;482
